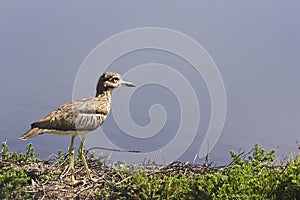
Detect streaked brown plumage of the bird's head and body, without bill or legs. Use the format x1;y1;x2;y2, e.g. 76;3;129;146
20;72;130;139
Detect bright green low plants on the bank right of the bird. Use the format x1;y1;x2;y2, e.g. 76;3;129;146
96;144;300;200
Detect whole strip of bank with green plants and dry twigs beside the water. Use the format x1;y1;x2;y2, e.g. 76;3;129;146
0;143;300;200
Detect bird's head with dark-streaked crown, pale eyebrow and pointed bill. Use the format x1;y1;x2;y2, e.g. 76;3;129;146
96;72;135;95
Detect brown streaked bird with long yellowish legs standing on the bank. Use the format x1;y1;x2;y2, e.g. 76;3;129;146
20;72;135;184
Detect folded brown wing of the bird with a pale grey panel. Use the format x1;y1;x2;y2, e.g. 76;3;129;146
31;98;107;131
